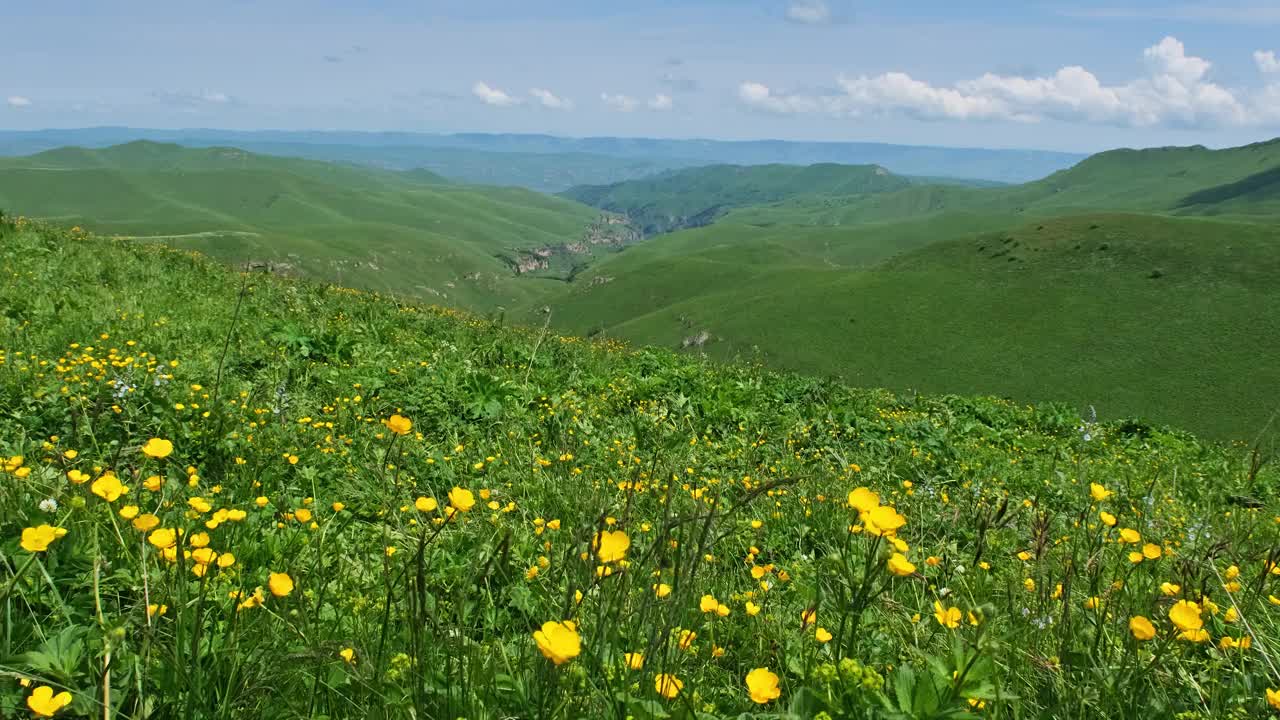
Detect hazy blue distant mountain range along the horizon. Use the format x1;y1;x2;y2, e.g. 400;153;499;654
0;127;1085;192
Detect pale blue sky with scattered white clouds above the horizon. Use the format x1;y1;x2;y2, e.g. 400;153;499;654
0;0;1280;151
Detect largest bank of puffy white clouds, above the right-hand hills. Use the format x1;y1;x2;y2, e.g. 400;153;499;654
739;37;1280;127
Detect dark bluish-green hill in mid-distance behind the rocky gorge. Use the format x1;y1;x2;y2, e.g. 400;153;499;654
563;164;911;234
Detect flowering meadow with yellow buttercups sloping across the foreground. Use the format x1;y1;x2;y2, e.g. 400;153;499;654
0;215;1280;719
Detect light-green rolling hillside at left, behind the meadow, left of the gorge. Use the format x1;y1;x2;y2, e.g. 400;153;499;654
0;142;596;307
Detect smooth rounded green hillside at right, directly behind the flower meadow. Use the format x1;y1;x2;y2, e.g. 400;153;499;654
543;214;1280;438
